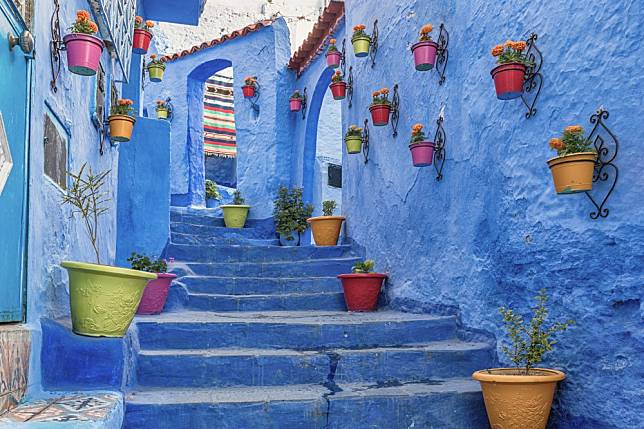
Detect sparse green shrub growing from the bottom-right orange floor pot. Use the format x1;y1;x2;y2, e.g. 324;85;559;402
499;289;575;375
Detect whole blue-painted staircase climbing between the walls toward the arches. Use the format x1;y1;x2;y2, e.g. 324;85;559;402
125;207;494;429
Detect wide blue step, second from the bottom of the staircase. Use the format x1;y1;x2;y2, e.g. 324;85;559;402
137;340;494;387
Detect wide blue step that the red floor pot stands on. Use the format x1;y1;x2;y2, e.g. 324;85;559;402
135;311;456;350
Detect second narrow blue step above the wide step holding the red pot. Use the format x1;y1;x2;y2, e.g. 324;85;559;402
181;276;342;295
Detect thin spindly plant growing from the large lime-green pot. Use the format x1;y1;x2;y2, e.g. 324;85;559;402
61;163;111;264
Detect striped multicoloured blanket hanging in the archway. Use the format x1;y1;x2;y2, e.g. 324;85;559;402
203;74;237;158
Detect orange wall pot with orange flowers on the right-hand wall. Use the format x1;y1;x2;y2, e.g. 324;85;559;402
548;125;597;194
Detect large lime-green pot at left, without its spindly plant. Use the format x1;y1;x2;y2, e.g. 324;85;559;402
60;261;157;337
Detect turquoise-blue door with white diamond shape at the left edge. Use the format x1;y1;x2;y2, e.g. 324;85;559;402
0;0;30;322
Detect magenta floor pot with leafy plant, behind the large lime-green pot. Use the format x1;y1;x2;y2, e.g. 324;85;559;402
127;252;177;314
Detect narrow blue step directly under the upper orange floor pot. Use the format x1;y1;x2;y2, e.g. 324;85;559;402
166;244;352;264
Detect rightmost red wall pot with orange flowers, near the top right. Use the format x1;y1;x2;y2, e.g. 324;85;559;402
490;40;532;100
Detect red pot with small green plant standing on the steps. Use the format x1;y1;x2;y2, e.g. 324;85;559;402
338;260;387;311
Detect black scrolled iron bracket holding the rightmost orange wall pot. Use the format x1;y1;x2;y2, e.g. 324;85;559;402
586;107;619;220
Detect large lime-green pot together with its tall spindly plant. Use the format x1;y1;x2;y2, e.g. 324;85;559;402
61;164;156;337
